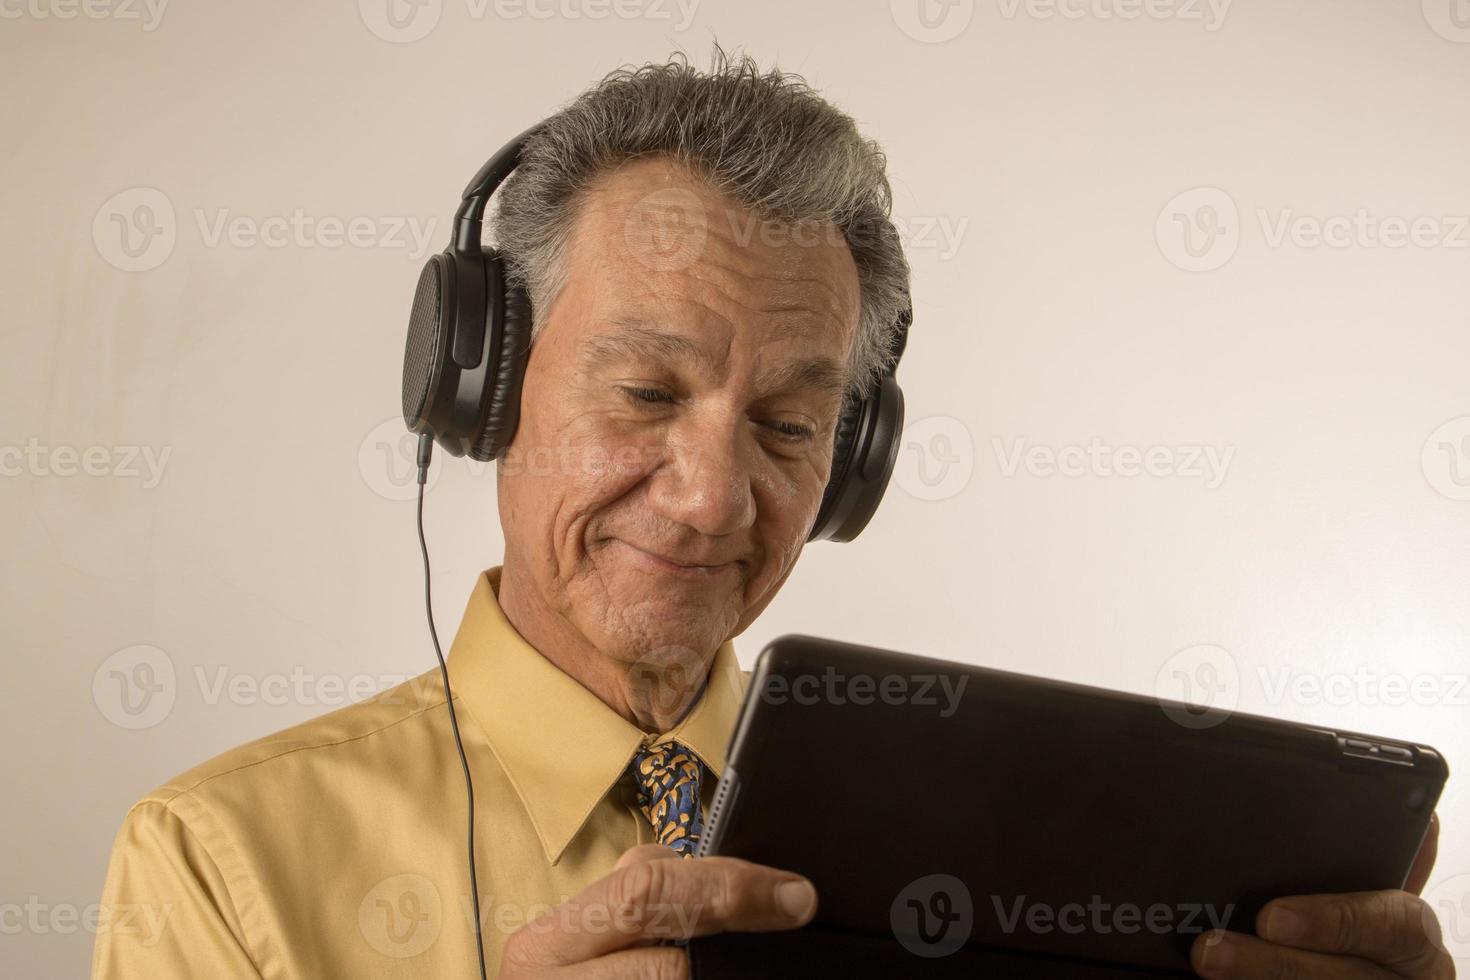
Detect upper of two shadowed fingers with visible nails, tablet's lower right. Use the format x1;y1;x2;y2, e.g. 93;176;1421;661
1255;890;1445;977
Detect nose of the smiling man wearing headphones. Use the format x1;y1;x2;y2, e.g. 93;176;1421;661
650;416;756;538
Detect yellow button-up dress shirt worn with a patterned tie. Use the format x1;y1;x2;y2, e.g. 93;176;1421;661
93;566;745;980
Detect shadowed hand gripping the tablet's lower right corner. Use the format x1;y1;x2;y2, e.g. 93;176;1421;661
1191;815;1455;980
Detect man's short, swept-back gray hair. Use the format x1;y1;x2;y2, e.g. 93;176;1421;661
494;44;908;398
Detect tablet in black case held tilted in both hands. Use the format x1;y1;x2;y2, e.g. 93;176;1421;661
689;635;1448;980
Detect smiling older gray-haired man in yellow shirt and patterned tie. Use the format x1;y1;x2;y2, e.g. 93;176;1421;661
94;49;1448;980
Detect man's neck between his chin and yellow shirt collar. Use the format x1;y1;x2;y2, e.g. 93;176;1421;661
495;554;714;733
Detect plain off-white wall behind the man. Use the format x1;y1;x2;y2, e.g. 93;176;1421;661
0;0;1470;977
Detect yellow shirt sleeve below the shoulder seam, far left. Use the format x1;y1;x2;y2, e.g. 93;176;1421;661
91;801;260;980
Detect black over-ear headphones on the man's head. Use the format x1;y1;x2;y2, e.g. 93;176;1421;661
403;123;913;541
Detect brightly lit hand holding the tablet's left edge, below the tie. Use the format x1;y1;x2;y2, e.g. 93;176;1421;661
500;843;817;980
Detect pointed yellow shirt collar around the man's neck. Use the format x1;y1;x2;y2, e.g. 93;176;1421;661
448;566;745;864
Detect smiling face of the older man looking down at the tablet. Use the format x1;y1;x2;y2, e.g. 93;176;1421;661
498;159;858;675
